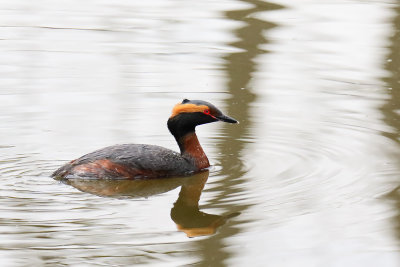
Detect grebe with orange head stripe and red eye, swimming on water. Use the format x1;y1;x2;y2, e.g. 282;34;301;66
52;99;238;179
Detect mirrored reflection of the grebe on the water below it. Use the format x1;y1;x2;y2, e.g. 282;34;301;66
56;171;238;237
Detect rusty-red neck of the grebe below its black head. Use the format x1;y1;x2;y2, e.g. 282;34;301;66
176;131;210;169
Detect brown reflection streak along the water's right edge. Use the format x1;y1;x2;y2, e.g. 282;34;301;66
382;1;400;248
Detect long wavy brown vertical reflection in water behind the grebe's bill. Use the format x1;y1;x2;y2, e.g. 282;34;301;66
193;0;281;266
